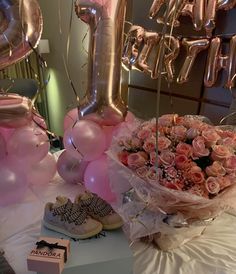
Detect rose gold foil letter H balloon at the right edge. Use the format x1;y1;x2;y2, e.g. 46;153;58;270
204;35;236;88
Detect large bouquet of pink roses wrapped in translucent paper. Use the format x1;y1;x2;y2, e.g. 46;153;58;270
108;114;236;249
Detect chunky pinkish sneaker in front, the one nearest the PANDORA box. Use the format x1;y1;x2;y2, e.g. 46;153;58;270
43;196;103;239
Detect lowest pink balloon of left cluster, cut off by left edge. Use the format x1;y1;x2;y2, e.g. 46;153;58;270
0;158;27;206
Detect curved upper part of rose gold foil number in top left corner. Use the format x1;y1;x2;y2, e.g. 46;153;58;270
0;0;43;70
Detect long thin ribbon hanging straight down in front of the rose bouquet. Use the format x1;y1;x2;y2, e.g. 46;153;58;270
155;2;170;180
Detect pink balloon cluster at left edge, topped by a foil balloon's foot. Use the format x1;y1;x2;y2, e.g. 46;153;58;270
0;94;56;206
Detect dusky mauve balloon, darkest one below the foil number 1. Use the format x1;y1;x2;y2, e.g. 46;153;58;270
57;150;88;184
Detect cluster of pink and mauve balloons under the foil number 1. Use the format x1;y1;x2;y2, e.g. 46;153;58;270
57;108;134;202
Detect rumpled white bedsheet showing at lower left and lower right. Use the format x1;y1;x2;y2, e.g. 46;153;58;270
0;176;236;274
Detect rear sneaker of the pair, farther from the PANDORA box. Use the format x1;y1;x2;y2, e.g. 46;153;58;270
75;191;123;230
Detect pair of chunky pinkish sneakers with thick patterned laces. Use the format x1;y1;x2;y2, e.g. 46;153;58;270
43;192;123;239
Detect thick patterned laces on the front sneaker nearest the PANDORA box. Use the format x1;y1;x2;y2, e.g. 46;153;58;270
53;199;87;225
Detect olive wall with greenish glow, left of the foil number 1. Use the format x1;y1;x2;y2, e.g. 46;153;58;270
39;0;88;135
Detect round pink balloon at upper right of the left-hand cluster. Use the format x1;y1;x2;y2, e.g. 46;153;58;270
7;127;50;164
